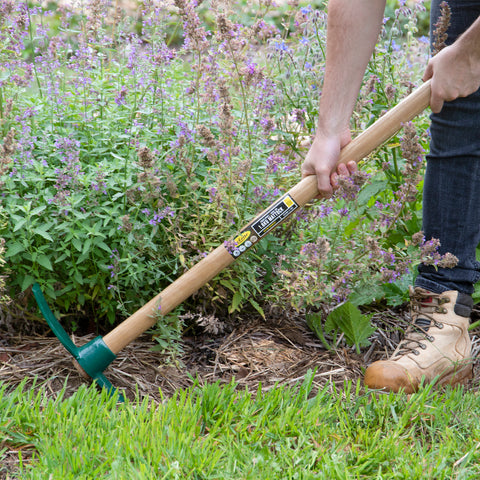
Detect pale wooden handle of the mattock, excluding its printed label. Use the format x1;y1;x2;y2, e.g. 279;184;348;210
103;81;430;354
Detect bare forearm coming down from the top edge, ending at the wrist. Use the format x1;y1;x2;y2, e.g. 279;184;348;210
318;0;385;134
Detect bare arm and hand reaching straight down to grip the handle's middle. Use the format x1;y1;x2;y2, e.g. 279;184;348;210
302;0;386;197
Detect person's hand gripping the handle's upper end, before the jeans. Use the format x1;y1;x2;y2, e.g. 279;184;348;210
423;41;480;113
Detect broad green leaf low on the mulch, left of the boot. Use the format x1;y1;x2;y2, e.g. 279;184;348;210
325;302;375;353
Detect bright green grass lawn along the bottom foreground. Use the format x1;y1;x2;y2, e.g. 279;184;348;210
0;376;480;479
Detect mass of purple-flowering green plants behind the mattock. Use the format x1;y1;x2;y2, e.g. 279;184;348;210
0;0;454;352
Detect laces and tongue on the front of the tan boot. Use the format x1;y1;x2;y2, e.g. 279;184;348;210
395;290;450;357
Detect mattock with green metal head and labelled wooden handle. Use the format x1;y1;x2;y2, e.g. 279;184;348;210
33;81;430;400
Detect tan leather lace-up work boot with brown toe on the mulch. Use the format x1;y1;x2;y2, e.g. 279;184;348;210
364;287;473;393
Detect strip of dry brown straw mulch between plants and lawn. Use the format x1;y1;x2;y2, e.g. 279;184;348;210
0;309;480;402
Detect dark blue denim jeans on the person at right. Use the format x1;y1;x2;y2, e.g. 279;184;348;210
415;0;480;294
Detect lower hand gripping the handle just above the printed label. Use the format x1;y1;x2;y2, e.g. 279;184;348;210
302;131;358;198
